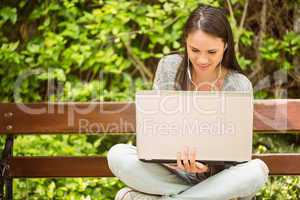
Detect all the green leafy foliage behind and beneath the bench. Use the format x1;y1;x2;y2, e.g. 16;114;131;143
0;0;300;199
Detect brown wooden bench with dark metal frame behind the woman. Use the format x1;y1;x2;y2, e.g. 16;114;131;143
0;99;300;199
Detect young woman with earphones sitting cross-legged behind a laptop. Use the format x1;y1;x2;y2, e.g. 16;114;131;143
107;6;269;200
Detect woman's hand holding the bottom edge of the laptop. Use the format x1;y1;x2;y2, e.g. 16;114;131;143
167;147;208;173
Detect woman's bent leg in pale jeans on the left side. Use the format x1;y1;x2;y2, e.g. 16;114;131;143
107;144;191;195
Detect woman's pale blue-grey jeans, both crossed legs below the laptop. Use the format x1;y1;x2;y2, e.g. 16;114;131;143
107;144;269;200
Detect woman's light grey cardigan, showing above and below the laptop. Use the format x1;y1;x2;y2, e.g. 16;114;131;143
152;54;253;184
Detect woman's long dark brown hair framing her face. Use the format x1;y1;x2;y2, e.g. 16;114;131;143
174;5;242;90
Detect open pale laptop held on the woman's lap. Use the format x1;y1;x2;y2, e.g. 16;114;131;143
136;90;253;164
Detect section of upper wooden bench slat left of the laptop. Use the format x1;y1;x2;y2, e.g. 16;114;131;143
0;102;135;134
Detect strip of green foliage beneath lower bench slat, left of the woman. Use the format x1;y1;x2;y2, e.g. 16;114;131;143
14;178;125;200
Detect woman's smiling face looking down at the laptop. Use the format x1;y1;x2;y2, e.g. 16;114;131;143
186;30;225;80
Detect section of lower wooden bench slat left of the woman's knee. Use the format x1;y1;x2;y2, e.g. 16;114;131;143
10;156;112;178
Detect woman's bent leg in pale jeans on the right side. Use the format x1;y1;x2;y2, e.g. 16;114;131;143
168;159;269;200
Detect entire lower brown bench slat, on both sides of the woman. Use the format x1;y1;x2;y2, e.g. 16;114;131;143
10;154;300;178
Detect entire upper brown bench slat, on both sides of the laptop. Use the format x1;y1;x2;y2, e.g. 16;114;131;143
0;99;300;134
